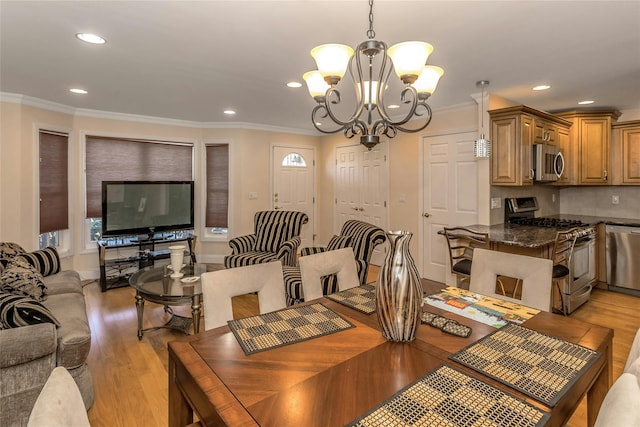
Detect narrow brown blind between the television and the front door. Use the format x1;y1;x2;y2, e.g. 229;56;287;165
205;144;229;228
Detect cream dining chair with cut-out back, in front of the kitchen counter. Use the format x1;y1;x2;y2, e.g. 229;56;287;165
469;249;553;311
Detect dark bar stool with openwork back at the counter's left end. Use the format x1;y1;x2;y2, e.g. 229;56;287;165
444;227;489;289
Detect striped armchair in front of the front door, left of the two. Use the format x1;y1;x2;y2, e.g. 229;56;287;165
224;210;309;268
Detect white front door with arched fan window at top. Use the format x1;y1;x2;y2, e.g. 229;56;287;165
271;145;315;248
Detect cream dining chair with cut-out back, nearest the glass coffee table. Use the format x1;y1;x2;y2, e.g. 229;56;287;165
200;261;286;330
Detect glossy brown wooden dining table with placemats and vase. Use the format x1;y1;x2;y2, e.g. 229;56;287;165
169;289;613;427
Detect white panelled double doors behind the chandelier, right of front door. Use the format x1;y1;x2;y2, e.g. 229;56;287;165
335;141;389;265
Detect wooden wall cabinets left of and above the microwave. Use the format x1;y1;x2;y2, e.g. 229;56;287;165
489;105;571;186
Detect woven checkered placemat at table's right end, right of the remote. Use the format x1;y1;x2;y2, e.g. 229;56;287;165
449;324;600;406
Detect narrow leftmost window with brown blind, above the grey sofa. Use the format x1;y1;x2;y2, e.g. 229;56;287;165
38;130;69;249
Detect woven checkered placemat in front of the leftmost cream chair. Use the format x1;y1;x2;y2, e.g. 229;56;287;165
227;304;354;354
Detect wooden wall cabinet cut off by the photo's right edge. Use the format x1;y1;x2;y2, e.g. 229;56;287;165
611;120;640;185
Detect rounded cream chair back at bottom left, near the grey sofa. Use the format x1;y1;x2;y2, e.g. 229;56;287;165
27;366;90;427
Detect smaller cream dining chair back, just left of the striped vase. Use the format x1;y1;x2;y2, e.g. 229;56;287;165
298;248;360;301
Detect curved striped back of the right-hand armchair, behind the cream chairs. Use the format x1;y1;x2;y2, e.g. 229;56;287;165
340;219;387;284
